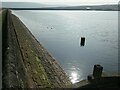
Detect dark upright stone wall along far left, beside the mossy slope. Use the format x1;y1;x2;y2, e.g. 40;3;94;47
2;11;28;88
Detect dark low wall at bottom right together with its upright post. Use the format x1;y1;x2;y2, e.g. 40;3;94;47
72;64;120;90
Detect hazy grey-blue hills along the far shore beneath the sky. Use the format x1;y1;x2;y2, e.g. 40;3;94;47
2;2;118;11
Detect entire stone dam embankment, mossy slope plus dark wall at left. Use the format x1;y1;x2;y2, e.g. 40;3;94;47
2;10;71;88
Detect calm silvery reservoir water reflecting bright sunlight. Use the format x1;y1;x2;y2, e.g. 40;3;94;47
13;10;118;83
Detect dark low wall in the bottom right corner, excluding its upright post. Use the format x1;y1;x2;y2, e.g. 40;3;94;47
74;76;120;90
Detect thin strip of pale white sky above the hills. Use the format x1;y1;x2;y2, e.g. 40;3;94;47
2;0;119;5
